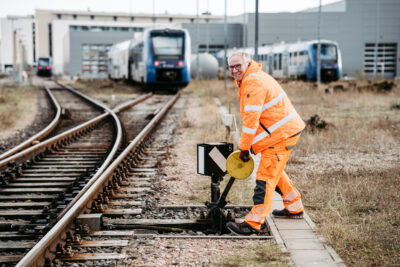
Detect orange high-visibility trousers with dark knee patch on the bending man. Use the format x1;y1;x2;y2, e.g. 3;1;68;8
244;135;303;230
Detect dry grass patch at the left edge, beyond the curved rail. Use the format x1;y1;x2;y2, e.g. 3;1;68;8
0;85;38;131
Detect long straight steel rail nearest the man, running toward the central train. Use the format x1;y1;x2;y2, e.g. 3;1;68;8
16;93;180;267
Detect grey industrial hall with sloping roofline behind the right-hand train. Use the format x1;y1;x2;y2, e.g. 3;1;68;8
229;0;400;78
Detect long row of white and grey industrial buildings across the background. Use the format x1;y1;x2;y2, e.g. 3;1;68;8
0;0;400;78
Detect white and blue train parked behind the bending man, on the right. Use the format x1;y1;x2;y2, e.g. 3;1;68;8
216;40;343;82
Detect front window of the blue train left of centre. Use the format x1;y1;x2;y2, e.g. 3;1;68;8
151;35;183;59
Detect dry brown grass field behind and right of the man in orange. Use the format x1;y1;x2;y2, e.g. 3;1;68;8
190;78;400;266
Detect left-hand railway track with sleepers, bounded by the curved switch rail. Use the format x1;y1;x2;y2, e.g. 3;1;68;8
0;82;155;262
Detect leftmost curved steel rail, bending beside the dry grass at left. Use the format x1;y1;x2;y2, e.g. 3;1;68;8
0;86;61;161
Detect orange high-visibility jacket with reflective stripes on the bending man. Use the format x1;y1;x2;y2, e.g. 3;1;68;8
236;61;305;154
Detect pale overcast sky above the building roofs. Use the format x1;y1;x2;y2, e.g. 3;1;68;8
0;0;339;17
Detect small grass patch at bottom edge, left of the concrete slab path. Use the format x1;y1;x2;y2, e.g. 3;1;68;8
216;242;290;267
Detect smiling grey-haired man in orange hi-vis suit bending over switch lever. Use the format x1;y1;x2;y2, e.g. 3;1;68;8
227;52;305;235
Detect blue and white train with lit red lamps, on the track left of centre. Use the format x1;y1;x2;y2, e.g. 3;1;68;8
108;28;191;92
